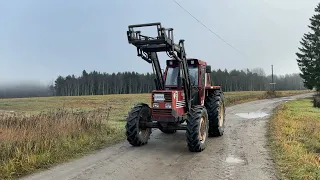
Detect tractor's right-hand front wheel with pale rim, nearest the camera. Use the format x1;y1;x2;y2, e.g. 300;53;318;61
186;106;209;152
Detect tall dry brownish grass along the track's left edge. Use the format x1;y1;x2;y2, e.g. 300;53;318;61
0;109;124;179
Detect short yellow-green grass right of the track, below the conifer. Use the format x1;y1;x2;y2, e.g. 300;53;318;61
269;99;320;179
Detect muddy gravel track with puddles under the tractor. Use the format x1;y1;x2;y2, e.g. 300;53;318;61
21;94;311;180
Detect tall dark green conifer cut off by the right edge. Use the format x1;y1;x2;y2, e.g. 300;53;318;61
296;3;320;91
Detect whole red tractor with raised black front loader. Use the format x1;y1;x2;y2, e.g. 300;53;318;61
126;23;225;152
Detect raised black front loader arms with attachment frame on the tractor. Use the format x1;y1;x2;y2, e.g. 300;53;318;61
127;23;191;112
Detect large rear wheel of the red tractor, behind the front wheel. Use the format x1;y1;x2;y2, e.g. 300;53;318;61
205;91;226;137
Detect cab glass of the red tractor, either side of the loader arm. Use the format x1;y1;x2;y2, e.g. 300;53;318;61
165;67;198;86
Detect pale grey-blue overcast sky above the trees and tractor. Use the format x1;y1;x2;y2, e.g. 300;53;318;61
0;0;318;83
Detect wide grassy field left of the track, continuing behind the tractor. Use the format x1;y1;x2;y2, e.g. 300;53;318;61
0;91;310;179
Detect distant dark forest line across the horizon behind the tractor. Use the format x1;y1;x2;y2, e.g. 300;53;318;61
53;68;305;96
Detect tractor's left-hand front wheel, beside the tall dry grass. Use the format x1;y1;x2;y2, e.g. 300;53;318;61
126;103;151;146
